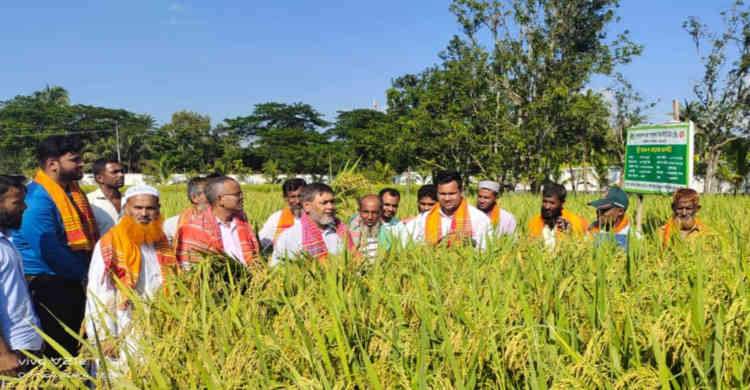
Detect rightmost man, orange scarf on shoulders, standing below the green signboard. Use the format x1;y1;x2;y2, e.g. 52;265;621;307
661;188;708;245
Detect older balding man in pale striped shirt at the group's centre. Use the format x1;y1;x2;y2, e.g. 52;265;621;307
349;194;391;259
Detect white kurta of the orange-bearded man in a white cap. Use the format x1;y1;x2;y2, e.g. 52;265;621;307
85;242;162;352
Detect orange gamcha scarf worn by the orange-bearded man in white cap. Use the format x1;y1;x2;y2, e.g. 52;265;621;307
99;215;178;309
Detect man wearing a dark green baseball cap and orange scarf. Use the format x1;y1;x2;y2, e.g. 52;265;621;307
588;187;630;252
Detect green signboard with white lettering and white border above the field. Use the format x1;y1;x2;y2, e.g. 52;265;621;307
623;122;695;194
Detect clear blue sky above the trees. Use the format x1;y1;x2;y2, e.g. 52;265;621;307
0;0;731;124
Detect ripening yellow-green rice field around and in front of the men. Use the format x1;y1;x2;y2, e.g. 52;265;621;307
7;186;750;389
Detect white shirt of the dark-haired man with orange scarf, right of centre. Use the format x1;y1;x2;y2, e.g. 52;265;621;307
399;205;492;250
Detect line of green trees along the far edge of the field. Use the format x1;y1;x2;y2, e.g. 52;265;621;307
0;0;750;193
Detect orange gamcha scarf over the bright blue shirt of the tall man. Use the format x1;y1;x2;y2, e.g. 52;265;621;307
34;171;99;252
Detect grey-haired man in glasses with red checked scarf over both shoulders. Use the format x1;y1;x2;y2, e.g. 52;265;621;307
175;176;260;266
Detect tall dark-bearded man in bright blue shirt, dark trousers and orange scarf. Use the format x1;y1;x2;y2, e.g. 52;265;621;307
13;135;99;359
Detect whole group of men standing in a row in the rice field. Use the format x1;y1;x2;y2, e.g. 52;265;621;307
0;136;707;375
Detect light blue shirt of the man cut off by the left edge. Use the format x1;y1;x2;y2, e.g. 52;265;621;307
0;232;42;351
